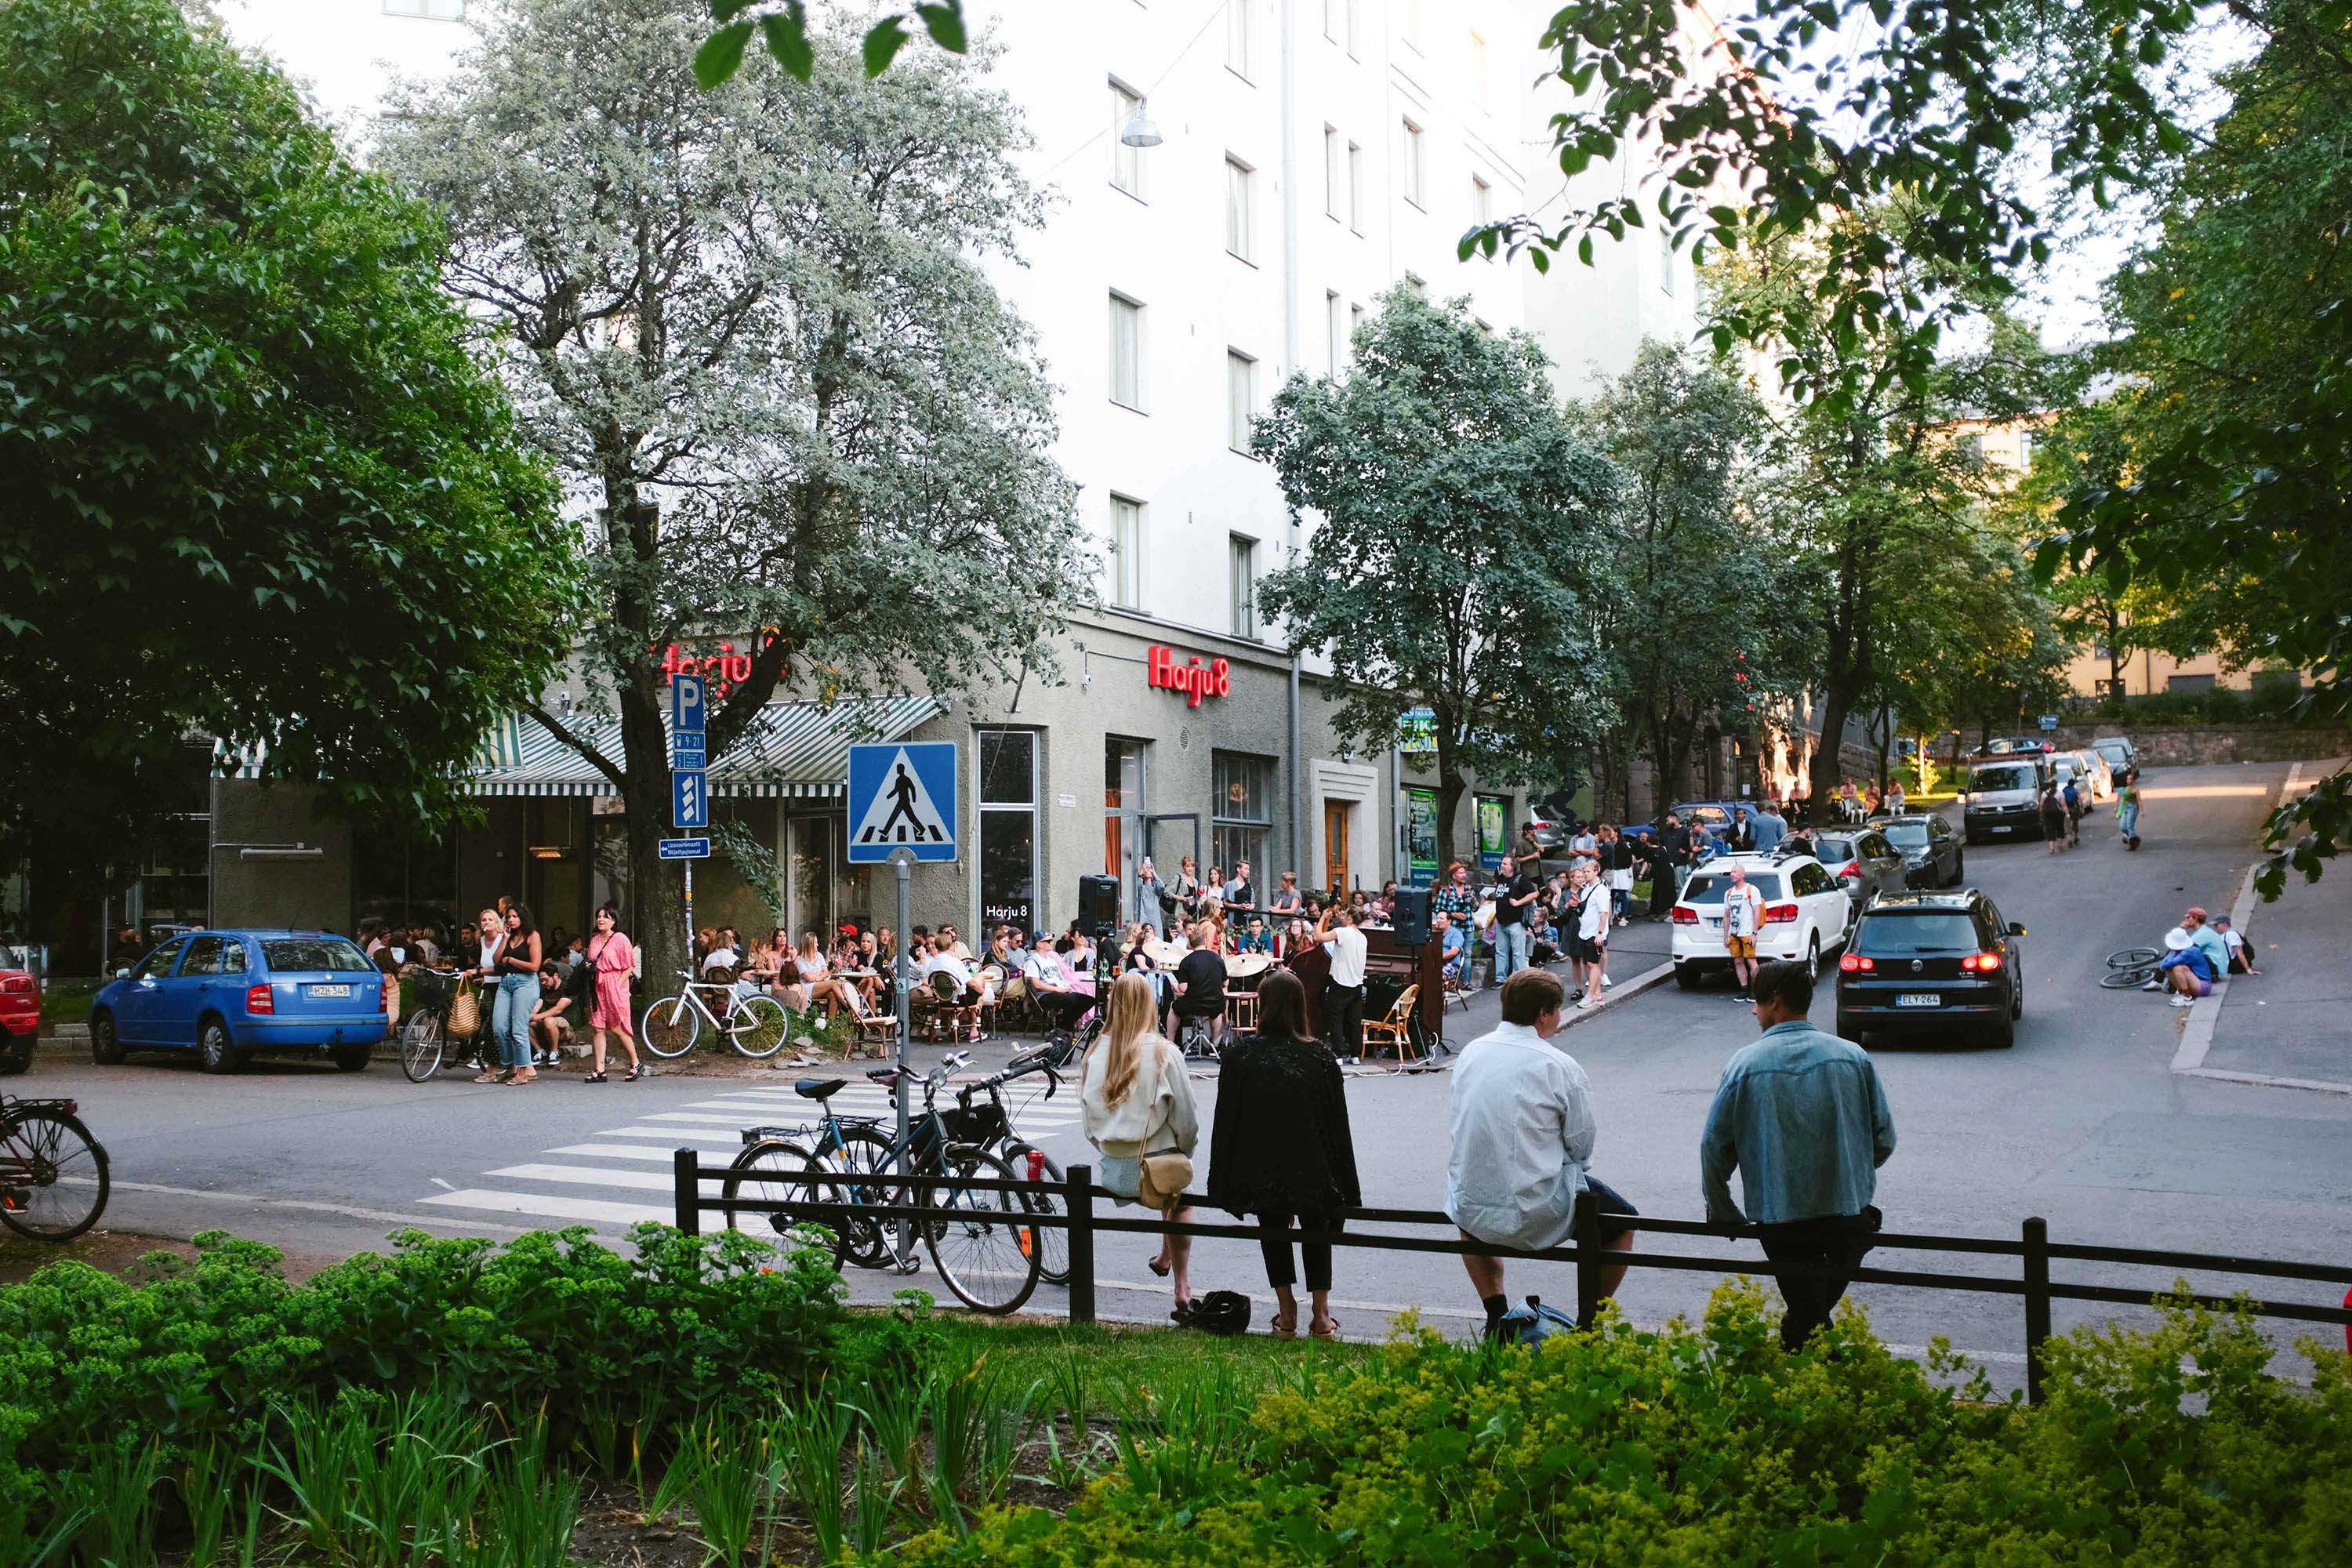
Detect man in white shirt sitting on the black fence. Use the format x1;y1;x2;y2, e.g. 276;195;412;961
1446;968;1637;1335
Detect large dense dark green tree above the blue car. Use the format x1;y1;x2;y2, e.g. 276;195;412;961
0;0;572;945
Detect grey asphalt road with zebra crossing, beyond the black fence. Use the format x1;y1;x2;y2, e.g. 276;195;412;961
12;767;2352;1382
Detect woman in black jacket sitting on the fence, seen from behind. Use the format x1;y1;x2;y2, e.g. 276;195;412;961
1209;968;1364;1340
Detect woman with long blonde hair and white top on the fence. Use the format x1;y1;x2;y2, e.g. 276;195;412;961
1080;971;1200;1321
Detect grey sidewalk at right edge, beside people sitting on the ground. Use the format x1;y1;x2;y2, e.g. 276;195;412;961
2173;762;2352;1095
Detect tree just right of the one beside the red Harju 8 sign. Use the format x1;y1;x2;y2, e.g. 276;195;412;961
1569;341;1811;818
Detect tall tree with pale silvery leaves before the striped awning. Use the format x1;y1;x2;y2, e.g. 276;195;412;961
383;0;1091;992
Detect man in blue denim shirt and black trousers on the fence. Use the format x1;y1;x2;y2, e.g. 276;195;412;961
1698;961;1896;1352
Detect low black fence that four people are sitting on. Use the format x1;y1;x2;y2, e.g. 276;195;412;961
673;1149;2352;1403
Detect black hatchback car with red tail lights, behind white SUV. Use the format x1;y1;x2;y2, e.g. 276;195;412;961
1837;888;2025;1046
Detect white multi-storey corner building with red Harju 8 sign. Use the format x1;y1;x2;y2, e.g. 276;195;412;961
202;0;1712;949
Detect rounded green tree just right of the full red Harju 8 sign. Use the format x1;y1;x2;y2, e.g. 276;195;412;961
1251;287;1618;846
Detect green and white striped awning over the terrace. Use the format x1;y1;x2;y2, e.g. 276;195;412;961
468;696;943;799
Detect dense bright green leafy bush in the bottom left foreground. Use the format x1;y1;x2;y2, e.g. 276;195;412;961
0;1225;842;1540
